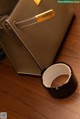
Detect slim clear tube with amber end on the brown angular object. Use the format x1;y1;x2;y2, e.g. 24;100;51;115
14;9;55;29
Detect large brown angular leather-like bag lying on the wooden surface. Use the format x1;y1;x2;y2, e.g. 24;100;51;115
0;0;73;75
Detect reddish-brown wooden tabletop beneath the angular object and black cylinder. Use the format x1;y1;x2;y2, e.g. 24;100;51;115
0;4;80;119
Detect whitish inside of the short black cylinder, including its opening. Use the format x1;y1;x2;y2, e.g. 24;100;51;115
42;63;71;88
